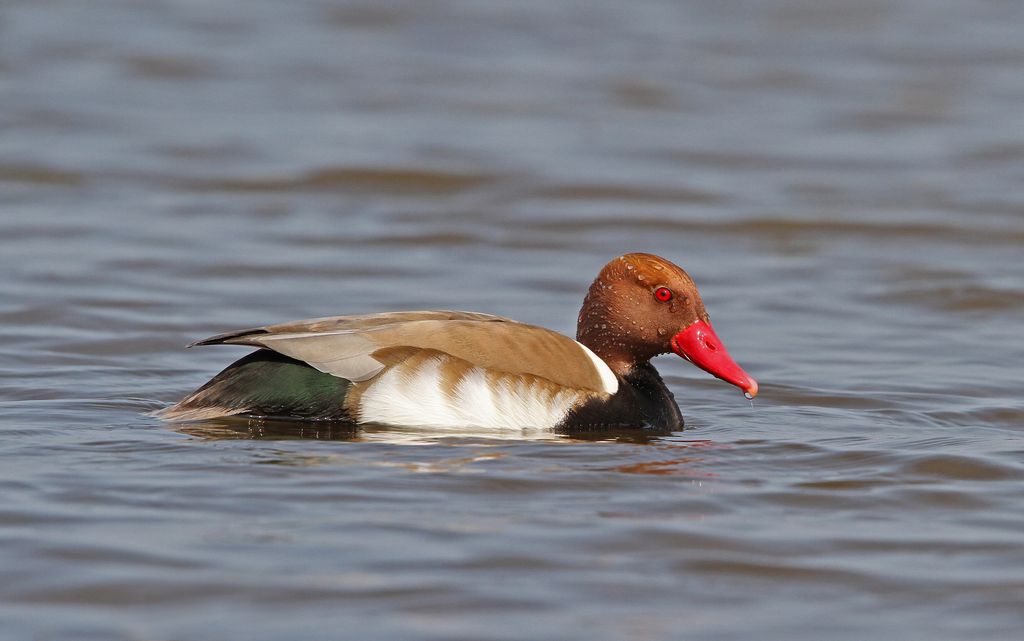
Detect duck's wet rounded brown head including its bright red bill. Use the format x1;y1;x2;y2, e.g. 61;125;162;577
577;254;758;396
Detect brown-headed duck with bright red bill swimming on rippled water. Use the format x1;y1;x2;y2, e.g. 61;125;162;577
155;253;758;431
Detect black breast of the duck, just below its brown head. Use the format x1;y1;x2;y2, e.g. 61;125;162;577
558;362;683;431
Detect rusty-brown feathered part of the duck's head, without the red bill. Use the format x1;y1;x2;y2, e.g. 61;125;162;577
577;253;708;375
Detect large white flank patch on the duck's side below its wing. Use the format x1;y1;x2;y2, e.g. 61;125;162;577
358;356;585;430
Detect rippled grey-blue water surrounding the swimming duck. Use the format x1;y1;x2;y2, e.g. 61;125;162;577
0;0;1024;641
